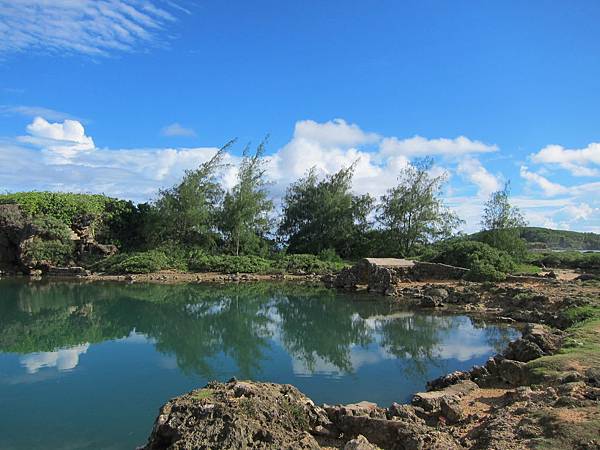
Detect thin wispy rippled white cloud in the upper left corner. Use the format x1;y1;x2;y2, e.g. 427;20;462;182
0;0;183;56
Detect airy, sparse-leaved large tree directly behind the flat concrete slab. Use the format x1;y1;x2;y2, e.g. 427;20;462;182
377;159;461;256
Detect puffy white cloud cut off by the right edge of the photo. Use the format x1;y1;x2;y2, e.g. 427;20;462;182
531;142;600;177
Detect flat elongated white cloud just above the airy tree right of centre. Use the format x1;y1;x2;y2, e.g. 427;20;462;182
381;136;498;157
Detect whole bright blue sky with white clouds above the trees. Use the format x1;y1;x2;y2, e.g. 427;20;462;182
0;0;600;231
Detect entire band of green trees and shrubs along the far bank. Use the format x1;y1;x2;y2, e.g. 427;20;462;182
0;141;600;280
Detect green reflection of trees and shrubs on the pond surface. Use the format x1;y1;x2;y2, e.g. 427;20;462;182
0;281;514;378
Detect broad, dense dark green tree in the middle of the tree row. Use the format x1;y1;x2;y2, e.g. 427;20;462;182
279;166;373;258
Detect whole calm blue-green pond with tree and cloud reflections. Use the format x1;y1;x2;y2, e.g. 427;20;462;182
0;280;518;449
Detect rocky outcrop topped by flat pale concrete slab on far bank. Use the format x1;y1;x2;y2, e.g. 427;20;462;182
330;258;468;294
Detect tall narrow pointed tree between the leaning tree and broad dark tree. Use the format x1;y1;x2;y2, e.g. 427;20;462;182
219;142;273;255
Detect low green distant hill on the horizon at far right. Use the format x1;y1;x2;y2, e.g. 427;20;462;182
521;227;600;250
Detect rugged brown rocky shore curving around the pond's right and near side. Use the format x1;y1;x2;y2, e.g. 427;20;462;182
144;281;600;450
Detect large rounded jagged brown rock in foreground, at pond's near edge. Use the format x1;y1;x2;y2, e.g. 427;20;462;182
145;380;332;450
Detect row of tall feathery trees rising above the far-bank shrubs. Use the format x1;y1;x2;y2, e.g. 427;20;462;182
139;141;525;259
